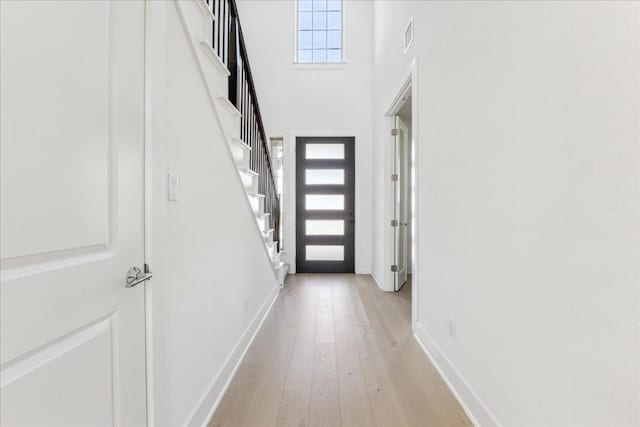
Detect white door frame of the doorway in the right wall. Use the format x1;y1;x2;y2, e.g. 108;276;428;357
380;58;420;332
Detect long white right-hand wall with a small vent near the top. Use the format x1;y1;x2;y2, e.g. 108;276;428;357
373;1;640;426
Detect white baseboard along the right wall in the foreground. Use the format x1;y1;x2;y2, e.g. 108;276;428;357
413;322;502;427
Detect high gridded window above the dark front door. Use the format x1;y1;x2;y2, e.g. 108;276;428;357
296;0;344;64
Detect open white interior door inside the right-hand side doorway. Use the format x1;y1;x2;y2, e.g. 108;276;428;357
394;117;410;291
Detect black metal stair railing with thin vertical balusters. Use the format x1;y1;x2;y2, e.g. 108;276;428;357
209;0;281;251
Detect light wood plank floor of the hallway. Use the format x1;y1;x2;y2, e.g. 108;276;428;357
209;274;472;427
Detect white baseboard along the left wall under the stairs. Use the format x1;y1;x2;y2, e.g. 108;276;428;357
188;286;280;427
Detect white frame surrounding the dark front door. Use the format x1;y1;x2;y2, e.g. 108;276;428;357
282;128;362;274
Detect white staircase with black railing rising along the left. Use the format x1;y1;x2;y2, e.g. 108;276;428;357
185;0;289;286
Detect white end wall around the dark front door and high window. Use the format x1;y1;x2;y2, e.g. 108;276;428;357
238;0;373;273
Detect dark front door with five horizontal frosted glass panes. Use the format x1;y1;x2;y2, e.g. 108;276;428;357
296;137;355;273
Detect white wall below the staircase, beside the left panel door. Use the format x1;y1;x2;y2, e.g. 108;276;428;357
147;2;278;426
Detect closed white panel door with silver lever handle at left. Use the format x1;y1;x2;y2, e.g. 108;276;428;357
0;0;146;426
